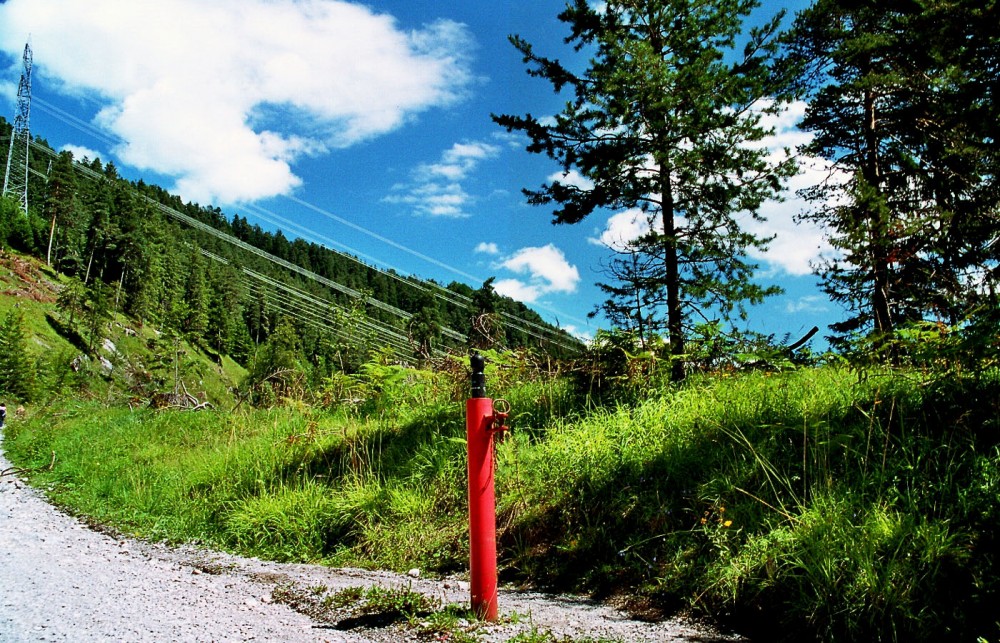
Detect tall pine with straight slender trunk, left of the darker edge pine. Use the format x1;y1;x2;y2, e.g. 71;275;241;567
494;0;795;380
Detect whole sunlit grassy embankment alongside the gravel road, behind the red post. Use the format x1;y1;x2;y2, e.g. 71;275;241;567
6;360;1000;640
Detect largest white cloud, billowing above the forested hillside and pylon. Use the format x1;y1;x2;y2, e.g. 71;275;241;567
0;0;471;202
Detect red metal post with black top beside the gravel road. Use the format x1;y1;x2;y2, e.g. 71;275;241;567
465;354;497;621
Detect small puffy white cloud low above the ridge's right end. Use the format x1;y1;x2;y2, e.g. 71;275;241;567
493;243;580;303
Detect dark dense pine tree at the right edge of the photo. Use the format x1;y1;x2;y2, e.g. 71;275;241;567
787;0;1000;352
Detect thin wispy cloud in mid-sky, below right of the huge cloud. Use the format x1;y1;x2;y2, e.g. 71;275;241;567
383;141;500;218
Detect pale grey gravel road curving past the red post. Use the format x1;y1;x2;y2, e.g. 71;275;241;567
0;433;736;643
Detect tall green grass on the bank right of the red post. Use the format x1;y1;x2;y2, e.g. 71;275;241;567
501;369;1000;640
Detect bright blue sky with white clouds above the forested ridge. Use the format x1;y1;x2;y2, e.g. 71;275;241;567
0;0;841;348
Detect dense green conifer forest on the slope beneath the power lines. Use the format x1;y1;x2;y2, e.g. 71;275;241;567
0;133;579;405
